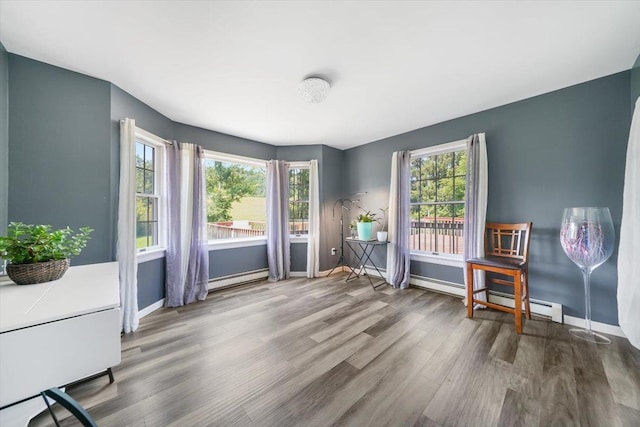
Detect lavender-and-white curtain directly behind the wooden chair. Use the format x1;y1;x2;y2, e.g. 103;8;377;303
464;133;489;305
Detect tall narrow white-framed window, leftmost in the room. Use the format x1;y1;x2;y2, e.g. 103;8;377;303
136;129;164;251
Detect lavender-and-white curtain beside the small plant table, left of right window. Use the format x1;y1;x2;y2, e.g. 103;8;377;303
387;151;411;289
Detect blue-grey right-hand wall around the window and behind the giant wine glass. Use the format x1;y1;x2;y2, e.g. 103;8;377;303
344;71;630;324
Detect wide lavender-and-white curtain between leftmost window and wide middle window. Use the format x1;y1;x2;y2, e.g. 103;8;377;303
165;142;209;307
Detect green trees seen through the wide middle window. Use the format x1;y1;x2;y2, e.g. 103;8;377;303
205;160;266;222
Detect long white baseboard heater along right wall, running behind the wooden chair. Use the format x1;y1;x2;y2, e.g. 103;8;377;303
363;266;563;323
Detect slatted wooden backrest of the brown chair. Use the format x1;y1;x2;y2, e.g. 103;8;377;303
484;222;533;262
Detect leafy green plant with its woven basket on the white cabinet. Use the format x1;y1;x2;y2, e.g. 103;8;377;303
0;222;93;285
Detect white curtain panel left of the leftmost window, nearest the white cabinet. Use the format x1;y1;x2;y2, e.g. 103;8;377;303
116;119;139;334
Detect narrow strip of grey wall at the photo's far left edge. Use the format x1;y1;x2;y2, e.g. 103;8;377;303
0;43;9;236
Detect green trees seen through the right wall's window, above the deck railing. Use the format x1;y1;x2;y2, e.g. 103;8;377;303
411;150;467;220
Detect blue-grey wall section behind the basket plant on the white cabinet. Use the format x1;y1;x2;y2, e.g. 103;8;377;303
8;54;113;265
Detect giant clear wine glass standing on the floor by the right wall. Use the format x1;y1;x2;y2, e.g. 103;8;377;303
560;208;615;344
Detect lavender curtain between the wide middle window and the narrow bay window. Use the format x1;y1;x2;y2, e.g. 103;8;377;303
267;160;291;281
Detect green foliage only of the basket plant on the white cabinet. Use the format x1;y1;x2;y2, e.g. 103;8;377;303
0;222;93;264
